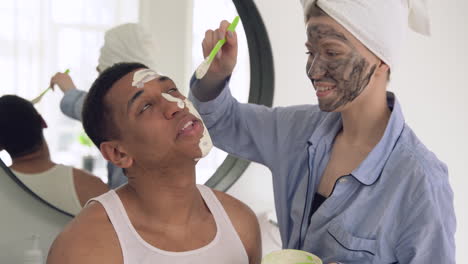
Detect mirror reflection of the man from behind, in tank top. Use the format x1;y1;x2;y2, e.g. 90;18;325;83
0;95;108;215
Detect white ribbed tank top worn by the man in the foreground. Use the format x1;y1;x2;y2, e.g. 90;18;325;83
88;185;249;264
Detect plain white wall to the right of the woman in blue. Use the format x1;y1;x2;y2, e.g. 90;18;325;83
392;0;468;263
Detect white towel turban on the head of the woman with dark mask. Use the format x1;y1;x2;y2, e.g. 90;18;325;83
300;0;430;69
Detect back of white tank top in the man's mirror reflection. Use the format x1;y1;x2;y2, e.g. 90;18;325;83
12;164;82;215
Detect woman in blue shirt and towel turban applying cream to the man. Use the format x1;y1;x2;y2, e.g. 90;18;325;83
191;0;456;263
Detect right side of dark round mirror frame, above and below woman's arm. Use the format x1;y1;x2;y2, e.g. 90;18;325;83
205;0;274;192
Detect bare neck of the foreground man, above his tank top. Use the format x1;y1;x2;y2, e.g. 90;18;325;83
117;163;206;226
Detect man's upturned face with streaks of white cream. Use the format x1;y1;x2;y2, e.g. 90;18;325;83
104;69;204;167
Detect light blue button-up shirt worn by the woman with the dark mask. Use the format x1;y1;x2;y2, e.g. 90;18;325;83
190;79;456;263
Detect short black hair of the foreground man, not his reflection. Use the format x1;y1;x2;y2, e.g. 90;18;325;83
82;62;148;148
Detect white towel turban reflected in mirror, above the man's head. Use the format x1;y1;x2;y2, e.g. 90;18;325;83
98;23;157;71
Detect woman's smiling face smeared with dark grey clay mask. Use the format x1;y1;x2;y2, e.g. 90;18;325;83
306;7;379;112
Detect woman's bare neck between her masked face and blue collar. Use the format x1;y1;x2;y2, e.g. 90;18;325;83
341;86;391;149
